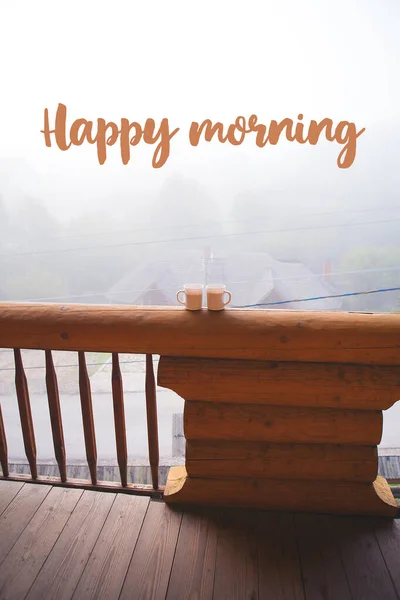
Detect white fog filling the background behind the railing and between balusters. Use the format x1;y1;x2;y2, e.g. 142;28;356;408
0;0;400;464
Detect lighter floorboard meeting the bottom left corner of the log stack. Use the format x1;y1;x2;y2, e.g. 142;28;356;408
120;502;182;600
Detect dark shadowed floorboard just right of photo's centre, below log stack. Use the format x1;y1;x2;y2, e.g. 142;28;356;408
213;509;262;600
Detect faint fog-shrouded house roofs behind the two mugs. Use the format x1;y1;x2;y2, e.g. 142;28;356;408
106;250;341;310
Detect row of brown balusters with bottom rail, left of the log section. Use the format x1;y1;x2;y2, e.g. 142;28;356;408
0;348;162;493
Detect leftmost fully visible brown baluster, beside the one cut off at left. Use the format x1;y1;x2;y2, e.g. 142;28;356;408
14;349;37;479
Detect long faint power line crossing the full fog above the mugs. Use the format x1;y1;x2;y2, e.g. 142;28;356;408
0;218;400;258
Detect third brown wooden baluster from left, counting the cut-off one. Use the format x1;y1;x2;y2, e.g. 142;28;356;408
45;350;67;482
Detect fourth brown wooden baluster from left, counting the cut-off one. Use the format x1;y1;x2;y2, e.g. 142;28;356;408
78;351;97;485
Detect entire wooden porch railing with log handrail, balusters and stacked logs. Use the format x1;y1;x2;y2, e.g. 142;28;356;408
0;304;400;516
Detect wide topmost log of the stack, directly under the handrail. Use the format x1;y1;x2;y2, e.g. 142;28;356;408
158;356;400;410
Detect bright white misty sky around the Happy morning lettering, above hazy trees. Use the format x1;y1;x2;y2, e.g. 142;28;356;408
0;0;400;216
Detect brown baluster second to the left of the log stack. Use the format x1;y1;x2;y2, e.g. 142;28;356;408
111;352;128;487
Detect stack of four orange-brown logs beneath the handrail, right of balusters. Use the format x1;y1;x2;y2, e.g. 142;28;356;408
158;356;400;516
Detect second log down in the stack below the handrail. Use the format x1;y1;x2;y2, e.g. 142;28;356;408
183;401;382;446
